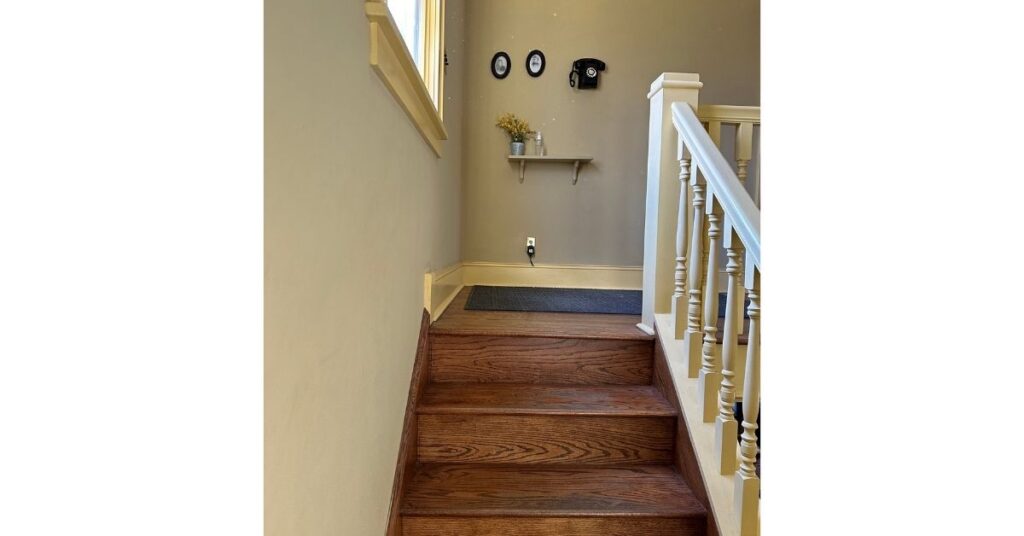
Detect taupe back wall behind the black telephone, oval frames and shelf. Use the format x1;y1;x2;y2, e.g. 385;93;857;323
462;0;760;265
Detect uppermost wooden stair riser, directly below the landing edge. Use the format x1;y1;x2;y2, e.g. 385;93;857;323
430;335;653;385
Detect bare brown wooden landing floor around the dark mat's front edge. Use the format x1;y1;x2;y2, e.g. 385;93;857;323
430;287;654;340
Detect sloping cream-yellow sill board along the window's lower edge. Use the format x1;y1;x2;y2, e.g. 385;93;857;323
366;1;447;158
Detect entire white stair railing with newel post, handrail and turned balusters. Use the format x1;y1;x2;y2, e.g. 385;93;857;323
640;73;761;536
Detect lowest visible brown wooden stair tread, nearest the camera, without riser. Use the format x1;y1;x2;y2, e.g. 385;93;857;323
401;463;707;518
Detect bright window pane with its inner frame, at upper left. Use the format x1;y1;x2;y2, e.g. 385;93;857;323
387;0;444;114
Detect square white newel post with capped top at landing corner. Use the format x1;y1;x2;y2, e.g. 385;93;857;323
638;73;703;334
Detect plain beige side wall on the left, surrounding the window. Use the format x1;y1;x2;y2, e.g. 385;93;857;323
262;0;463;536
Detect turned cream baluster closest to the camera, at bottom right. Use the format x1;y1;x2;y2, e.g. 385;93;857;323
733;264;761;536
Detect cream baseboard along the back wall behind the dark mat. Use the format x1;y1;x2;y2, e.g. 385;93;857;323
462;262;643;290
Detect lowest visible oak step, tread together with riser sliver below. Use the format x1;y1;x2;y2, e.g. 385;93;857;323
401;464;707;536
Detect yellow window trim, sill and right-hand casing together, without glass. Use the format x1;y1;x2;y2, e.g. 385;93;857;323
366;1;447;158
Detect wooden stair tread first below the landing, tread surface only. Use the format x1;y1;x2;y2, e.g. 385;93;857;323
417;383;676;416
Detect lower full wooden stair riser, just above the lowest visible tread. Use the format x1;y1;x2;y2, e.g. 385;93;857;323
417;415;676;465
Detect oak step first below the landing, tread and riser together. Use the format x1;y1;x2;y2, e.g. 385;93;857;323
417;383;676;465
